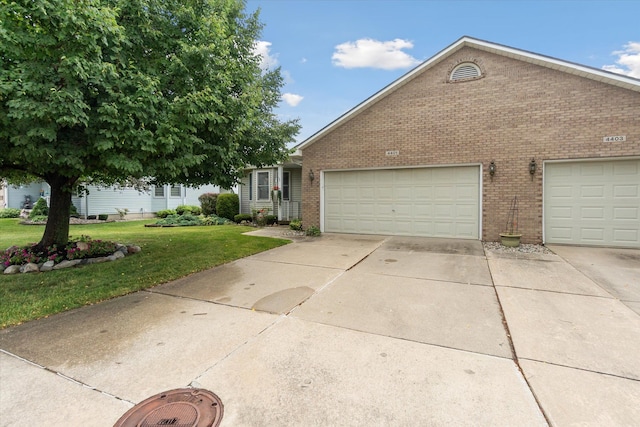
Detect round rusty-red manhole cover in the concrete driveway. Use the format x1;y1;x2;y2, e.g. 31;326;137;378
113;388;224;427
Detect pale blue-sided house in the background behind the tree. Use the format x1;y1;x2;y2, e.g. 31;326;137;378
0;182;227;218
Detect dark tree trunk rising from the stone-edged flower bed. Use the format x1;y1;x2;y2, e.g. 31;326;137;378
38;176;76;248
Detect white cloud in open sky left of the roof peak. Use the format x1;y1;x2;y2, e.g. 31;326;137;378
331;39;420;70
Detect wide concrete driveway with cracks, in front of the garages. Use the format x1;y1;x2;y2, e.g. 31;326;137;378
0;229;640;426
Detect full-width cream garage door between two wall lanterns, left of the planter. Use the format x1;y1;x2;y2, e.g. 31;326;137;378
324;166;480;239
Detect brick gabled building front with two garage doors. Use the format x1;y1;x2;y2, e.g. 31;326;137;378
298;37;640;248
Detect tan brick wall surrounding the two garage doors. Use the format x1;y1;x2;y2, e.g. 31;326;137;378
302;47;640;243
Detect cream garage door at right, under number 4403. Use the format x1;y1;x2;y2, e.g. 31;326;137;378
544;160;640;247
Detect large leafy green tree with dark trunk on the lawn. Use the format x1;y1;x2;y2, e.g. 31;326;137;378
0;0;298;246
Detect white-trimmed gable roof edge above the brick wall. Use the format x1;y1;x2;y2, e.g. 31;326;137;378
295;36;640;152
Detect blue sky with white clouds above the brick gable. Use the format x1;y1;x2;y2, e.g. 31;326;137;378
246;0;640;142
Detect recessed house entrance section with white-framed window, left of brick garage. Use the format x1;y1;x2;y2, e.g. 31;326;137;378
238;153;302;221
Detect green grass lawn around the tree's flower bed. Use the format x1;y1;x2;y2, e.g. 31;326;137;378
0;219;288;328
